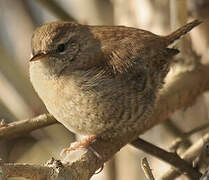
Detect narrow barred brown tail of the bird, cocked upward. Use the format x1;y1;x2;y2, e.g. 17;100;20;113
165;20;201;45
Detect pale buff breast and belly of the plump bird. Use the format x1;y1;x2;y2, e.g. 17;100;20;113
30;63;153;135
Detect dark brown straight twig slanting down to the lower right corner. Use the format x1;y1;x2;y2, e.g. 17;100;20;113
131;138;201;180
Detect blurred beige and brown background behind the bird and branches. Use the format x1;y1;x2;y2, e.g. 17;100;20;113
0;0;209;180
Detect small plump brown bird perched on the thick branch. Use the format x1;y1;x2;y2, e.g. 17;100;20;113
30;20;200;152
